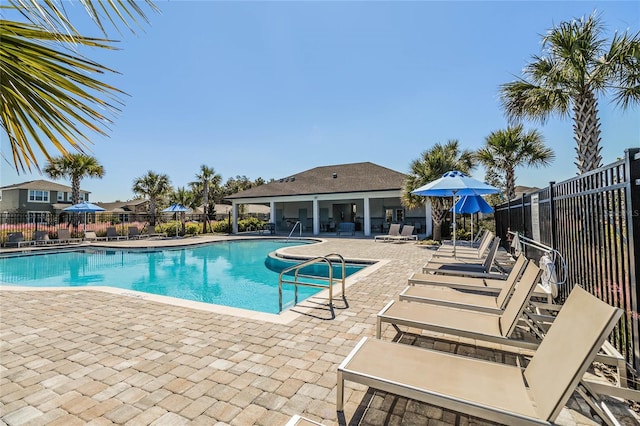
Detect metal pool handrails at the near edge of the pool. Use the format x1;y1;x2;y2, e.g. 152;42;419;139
278;253;347;318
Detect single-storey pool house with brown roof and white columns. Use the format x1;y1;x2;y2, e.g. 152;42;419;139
225;162;432;236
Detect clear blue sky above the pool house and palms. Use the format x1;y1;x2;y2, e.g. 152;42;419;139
0;1;640;202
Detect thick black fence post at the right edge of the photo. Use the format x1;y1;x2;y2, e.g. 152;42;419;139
625;148;640;376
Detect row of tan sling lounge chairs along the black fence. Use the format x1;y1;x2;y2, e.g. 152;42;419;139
337;233;640;424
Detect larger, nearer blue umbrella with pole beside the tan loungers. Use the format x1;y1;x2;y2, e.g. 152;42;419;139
411;170;500;256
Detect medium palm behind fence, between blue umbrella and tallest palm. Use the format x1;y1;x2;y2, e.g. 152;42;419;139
475;125;555;200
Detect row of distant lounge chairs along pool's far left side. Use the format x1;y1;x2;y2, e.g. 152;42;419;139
5;225;166;247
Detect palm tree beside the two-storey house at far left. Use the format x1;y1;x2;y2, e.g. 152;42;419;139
44;154;105;204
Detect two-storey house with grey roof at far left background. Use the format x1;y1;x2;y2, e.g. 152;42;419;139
0;179;90;223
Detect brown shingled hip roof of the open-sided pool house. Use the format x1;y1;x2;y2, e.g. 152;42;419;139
226;162;405;200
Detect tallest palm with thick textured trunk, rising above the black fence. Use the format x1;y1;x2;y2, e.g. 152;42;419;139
500;14;640;173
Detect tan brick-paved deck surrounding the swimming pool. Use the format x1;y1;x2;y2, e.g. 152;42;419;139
0;236;638;426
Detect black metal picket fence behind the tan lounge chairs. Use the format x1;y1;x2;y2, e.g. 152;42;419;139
495;148;640;374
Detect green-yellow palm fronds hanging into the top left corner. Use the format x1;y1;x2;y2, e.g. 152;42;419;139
0;0;157;172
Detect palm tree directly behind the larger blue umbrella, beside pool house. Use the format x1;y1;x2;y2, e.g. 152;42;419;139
401;140;475;241
